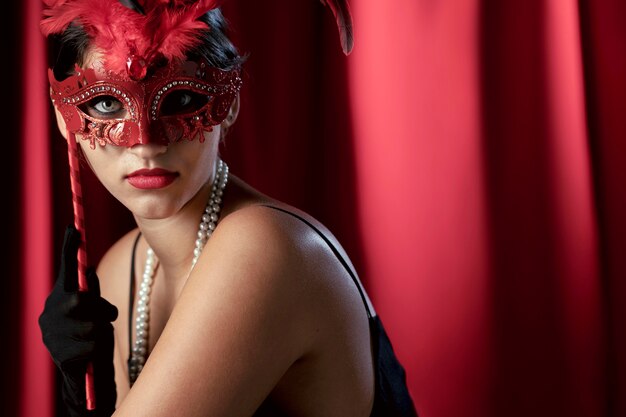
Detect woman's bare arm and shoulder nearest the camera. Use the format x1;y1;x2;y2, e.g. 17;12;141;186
115;207;316;417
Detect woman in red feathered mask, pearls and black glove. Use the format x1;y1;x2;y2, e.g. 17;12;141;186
40;0;415;417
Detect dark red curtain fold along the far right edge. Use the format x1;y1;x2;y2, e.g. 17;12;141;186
578;0;626;416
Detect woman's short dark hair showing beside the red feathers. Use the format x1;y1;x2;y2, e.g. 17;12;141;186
52;4;245;80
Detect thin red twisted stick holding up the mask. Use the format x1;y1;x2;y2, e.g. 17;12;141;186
67;132;96;410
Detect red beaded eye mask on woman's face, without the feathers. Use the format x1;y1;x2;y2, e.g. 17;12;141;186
48;60;242;149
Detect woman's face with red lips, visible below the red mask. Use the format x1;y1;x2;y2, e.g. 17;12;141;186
56;53;236;219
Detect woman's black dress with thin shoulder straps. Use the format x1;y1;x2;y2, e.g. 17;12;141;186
128;206;417;417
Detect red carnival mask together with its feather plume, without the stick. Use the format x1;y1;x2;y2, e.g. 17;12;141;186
41;0;353;148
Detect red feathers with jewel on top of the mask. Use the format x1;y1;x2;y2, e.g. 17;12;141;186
41;0;353;79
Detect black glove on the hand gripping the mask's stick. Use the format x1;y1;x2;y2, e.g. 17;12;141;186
39;226;117;417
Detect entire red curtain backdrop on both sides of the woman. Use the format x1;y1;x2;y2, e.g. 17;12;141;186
11;0;626;417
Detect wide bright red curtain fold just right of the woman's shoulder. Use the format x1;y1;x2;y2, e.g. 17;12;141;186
348;0;492;416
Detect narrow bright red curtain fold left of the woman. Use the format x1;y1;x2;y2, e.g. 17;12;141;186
19;1;54;417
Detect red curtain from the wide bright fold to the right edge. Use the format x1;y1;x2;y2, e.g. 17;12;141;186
348;0;626;417
